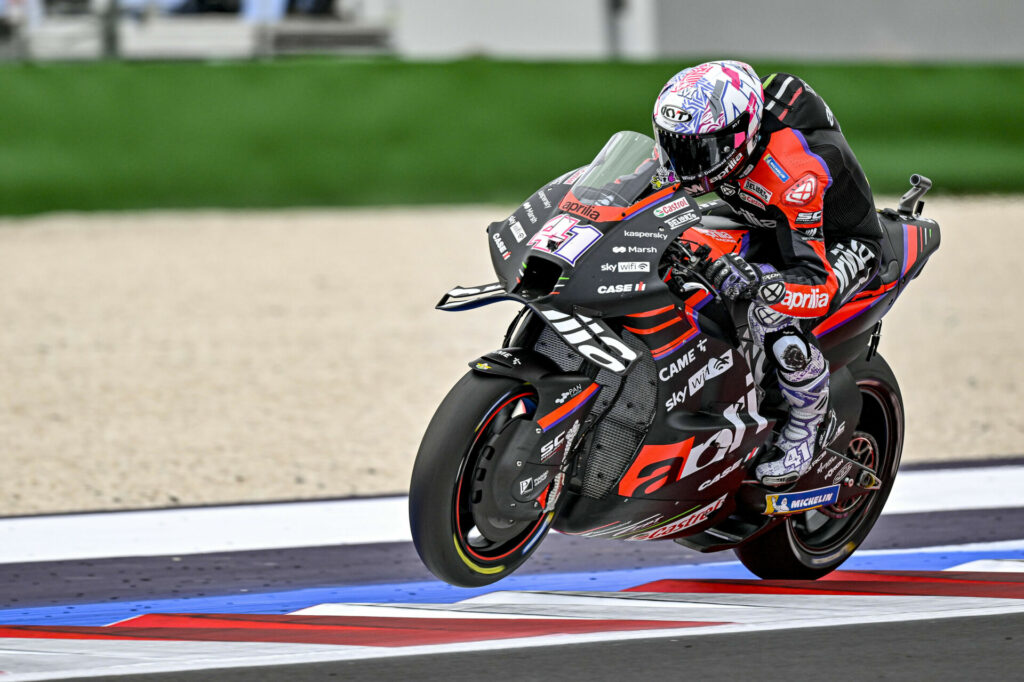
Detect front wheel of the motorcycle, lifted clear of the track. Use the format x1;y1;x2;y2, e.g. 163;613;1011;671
409;372;554;587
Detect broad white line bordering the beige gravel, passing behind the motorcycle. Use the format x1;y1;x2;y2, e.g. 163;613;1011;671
0;465;1024;563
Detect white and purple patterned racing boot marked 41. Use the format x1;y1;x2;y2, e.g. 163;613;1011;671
755;358;828;486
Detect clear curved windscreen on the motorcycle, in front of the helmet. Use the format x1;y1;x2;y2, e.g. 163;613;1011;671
572;130;660;207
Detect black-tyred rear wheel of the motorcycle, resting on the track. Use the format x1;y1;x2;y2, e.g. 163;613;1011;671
735;354;903;580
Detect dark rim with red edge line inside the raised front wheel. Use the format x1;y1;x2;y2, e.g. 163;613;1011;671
454;387;552;563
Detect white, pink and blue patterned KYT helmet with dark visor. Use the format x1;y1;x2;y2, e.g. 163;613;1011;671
653;60;764;194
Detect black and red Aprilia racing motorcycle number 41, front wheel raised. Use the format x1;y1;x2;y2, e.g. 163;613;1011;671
409;132;939;587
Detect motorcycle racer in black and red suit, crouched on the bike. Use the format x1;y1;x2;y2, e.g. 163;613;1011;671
653;60;882;485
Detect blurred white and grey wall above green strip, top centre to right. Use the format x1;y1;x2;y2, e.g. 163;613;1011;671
393;0;1024;61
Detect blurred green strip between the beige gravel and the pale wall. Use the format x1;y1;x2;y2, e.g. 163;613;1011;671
0;59;1024;214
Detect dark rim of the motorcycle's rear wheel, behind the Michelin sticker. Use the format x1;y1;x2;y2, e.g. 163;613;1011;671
786;380;903;556
